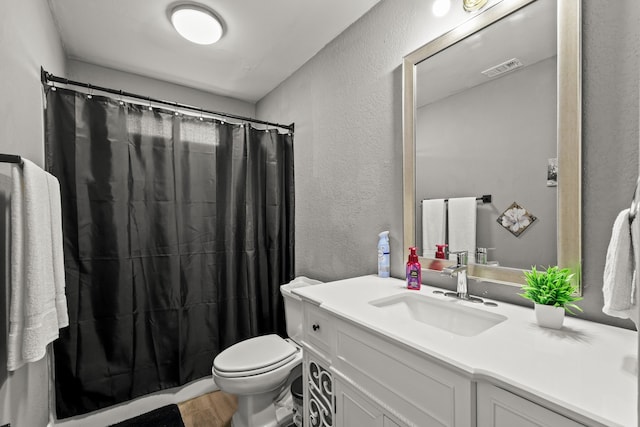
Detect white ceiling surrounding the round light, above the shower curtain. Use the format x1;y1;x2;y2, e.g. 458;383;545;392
48;0;380;103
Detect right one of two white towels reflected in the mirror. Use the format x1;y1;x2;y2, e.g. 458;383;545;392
448;197;478;263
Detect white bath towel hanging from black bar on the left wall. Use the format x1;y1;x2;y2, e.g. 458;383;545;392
7;160;69;371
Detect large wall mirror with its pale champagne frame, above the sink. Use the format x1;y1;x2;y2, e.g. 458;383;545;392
403;0;581;292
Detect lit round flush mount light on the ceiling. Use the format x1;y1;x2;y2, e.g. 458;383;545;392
169;3;223;45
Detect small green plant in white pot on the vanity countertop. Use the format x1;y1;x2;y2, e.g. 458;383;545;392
519;266;582;329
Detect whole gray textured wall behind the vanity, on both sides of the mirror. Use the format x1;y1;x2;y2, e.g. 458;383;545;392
257;0;640;327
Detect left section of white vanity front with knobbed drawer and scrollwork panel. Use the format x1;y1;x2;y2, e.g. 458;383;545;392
303;302;475;427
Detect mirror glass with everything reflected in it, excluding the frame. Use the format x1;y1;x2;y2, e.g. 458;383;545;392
415;0;557;269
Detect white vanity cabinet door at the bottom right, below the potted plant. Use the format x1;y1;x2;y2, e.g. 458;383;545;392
477;383;582;427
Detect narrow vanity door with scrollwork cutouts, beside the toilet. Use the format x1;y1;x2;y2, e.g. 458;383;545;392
304;355;335;427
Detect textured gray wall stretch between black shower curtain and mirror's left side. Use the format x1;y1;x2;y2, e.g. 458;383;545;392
257;0;480;280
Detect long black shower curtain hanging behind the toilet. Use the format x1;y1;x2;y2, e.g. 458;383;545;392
46;88;294;418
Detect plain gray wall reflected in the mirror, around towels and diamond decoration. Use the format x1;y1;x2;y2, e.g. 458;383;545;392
416;56;558;269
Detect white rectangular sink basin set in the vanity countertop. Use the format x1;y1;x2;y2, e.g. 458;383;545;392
369;294;507;337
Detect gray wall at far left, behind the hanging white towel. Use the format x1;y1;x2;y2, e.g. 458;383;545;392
0;0;65;426
